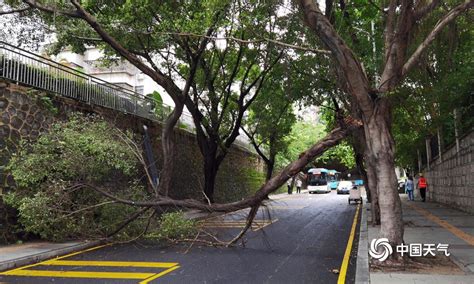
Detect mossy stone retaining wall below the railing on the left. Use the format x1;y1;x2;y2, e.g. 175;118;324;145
0;80;264;243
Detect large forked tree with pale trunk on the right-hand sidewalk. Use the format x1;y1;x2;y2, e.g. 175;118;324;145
299;0;474;245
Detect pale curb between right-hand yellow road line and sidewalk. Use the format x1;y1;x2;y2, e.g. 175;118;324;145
355;202;370;284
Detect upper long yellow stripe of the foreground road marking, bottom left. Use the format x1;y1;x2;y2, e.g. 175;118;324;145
41;260;178;268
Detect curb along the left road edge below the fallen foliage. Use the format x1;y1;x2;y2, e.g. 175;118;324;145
0;240;103;271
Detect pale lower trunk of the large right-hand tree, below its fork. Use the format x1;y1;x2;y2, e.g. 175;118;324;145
363;98;403;245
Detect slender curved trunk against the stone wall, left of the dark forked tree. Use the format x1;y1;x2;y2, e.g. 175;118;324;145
159;104;183;196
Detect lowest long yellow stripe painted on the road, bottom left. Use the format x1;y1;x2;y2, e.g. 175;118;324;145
4;270;155;279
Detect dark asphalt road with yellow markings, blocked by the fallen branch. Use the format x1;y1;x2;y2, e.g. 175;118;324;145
0;192;358;283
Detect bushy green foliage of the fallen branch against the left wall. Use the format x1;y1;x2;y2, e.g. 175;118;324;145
4;115;144;241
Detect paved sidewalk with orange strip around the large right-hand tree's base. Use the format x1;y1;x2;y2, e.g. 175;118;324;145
356;195;474;284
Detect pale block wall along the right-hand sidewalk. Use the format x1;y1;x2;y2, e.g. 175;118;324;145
426;131;474;213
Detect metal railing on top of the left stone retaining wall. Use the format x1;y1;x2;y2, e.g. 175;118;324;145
0;41;255;153
